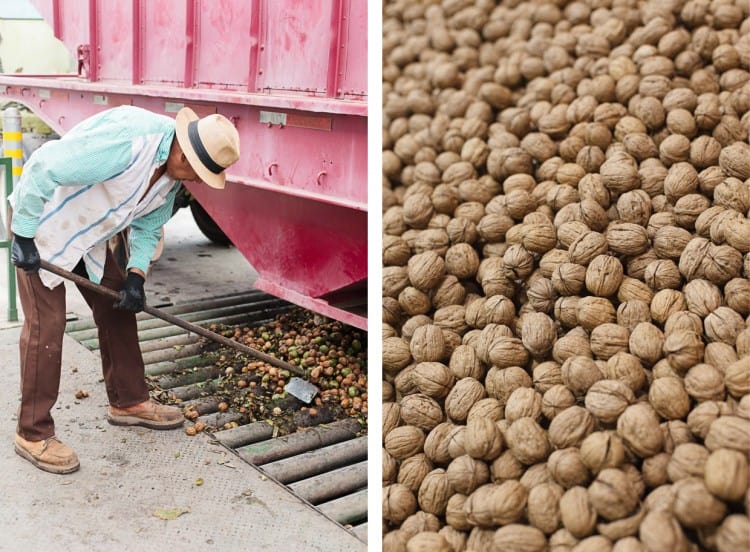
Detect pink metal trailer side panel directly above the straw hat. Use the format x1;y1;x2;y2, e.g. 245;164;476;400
194;0;252;89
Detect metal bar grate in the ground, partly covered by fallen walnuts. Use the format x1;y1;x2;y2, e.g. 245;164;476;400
66;291;367;542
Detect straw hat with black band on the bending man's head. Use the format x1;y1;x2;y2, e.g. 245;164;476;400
175;107;240;189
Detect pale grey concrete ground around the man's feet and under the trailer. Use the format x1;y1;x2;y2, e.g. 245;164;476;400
0;210;367;552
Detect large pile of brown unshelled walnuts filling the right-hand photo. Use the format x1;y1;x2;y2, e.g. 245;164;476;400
382;0;750;552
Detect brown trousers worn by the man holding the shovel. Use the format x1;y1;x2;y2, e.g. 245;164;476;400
16;250;149;441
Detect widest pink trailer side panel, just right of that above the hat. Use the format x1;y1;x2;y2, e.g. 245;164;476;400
256;0;333;95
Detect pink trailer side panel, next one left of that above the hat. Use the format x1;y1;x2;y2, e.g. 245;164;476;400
140;0;188;86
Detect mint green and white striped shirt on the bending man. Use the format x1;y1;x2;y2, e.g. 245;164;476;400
8;106;179;287
